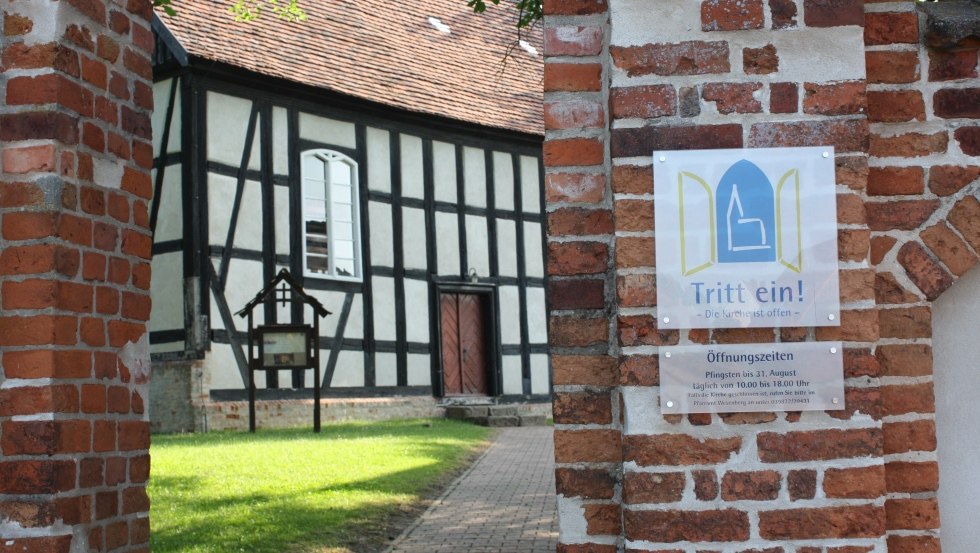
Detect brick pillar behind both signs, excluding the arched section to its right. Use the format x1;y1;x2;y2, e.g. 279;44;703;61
544;0;918;553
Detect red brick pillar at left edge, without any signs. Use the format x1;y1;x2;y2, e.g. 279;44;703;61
0;0;153;552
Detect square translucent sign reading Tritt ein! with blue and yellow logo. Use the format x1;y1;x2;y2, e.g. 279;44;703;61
653;146;840;328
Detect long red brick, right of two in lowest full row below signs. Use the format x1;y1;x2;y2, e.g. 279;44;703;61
759;505;885;540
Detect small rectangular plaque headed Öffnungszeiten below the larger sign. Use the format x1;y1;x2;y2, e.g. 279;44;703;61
660;342;844;413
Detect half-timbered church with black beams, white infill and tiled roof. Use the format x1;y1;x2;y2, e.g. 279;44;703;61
148;0;550;430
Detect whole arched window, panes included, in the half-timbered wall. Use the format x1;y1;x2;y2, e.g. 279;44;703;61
302;150;361;280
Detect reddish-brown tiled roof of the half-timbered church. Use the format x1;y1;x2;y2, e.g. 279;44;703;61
161;0;544;135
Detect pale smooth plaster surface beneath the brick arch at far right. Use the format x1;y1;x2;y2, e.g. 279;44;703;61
932;269;980;553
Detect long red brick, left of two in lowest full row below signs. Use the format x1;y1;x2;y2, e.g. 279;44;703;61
623;509;749;543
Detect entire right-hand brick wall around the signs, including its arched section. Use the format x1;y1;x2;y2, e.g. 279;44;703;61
544;0;980;553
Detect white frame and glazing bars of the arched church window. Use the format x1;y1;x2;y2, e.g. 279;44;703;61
299;149;363;282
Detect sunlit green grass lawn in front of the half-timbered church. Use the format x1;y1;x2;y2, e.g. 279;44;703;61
149;419;489;553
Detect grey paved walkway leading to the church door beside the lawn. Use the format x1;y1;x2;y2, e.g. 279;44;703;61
386;426;558;553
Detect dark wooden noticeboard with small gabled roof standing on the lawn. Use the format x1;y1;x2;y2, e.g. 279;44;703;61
237;269;330;432
